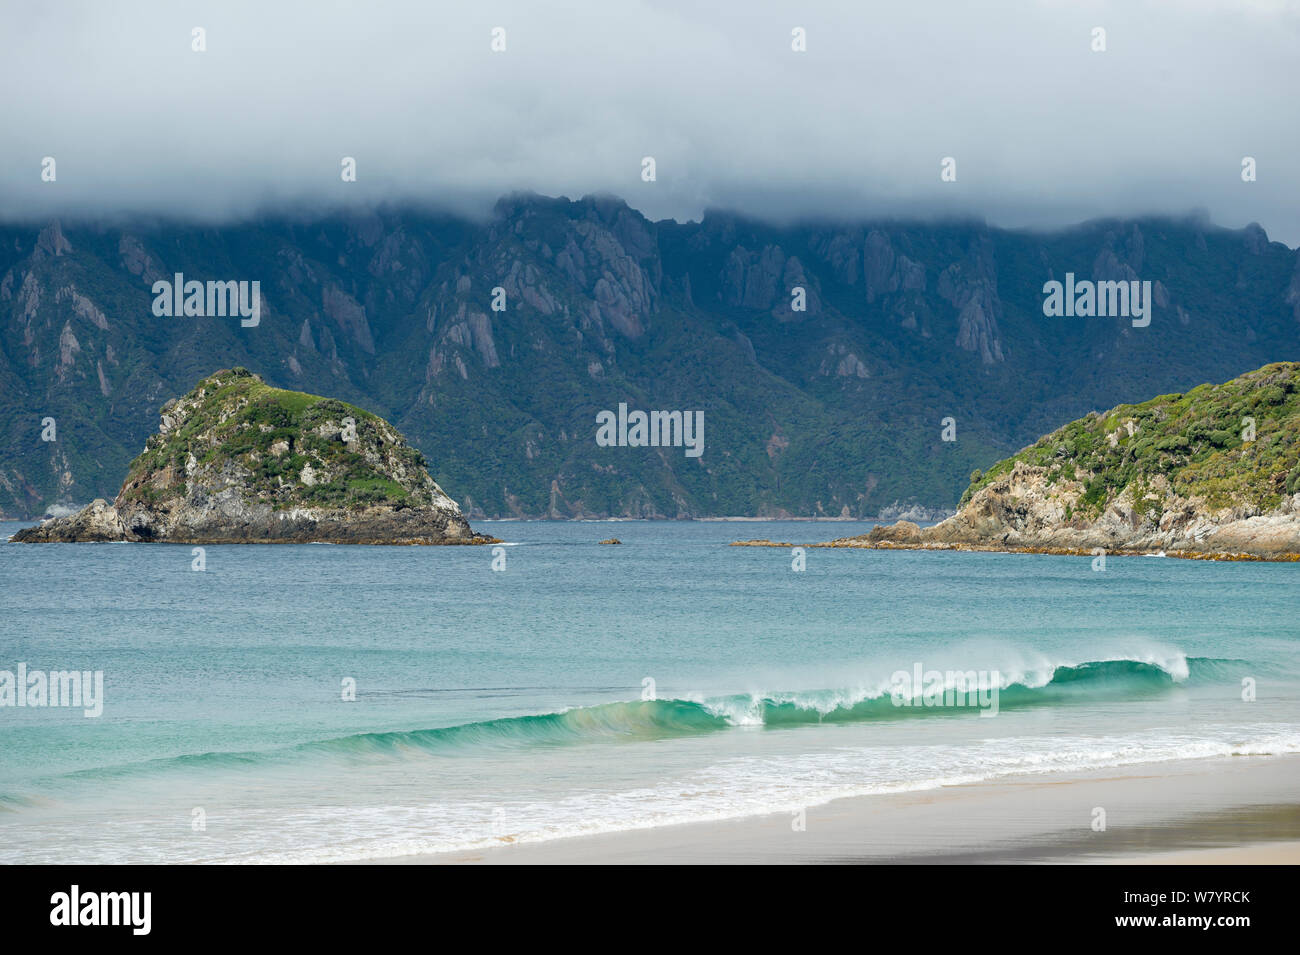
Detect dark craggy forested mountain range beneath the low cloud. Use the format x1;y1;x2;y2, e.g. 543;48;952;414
0;194;1300;517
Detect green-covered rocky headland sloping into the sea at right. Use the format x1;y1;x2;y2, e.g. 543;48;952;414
737;363;1300;560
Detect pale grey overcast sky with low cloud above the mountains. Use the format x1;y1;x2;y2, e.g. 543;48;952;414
0;0;1300;246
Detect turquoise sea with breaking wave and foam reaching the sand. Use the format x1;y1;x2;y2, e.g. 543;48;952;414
0;522;1300;861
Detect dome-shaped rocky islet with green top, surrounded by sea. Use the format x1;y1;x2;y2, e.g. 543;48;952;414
12;368;495;544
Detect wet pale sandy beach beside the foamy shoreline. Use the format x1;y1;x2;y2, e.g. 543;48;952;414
380;756;1300;864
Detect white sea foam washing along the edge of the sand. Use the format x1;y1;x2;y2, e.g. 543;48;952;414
209;726;1300;863
